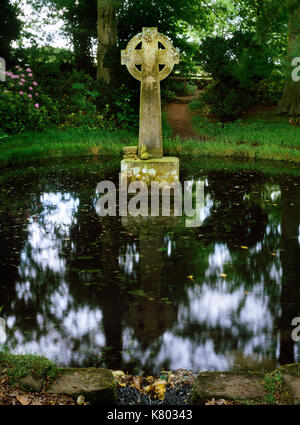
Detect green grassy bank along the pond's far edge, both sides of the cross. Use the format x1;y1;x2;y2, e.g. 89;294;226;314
0;107;300;166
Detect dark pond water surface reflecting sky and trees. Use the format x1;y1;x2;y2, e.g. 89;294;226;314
0;159;300;373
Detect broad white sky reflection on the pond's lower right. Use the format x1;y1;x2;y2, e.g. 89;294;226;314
123;255;274;370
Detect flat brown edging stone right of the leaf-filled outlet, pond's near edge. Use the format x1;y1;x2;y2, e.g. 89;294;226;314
192;372;266;404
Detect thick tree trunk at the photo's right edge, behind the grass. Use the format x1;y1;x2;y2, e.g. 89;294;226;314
276;6;300;116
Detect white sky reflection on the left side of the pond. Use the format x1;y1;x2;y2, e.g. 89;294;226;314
8;193;105;363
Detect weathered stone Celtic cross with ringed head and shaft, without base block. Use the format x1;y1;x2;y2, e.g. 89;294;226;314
121;27;179;158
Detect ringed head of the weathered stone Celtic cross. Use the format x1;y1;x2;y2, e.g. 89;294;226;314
121;28;179;81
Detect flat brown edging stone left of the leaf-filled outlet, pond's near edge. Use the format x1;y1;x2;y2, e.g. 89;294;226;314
46;367;116;405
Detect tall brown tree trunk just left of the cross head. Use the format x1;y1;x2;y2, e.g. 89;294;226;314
97;0;117;83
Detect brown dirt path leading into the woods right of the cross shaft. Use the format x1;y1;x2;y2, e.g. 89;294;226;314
165;92;203;140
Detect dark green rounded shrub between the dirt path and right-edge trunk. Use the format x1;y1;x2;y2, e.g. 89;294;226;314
196;31;274;121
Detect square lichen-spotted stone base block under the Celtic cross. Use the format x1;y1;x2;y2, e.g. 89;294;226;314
121;157;179;186
